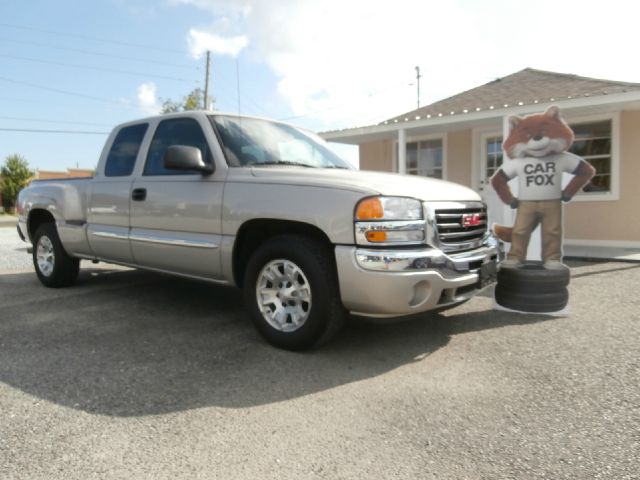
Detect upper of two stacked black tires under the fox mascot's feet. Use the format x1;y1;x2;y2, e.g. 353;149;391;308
498;264;571;293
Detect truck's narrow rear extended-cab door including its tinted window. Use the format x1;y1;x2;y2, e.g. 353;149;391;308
87;123;149;264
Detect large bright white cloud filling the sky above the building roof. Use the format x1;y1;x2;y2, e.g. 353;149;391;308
173;0;640;128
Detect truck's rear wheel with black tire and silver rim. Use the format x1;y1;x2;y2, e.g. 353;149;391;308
33;223;80;288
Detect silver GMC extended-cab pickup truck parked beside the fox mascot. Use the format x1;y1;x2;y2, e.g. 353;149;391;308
18;112;498;349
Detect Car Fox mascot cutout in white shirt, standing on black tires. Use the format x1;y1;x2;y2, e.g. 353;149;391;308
491;106;595;312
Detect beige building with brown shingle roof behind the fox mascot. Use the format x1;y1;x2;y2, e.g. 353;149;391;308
321;69;640;255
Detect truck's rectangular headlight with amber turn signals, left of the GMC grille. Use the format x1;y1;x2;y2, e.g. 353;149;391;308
355;197;425;246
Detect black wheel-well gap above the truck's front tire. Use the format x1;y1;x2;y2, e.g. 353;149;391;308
233;219;333;288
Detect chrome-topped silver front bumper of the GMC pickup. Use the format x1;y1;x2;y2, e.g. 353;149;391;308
336;238;499;317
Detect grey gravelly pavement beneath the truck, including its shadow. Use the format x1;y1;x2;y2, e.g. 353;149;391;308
0;229;640;480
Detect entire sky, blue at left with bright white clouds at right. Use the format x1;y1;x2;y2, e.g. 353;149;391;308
0;0;640;170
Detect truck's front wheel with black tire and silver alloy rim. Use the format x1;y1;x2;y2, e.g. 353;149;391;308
244;235;346;350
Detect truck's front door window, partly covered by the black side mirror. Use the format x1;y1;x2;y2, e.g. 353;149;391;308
143;118;212;175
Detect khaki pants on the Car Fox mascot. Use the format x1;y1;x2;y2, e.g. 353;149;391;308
507;200;562;262
